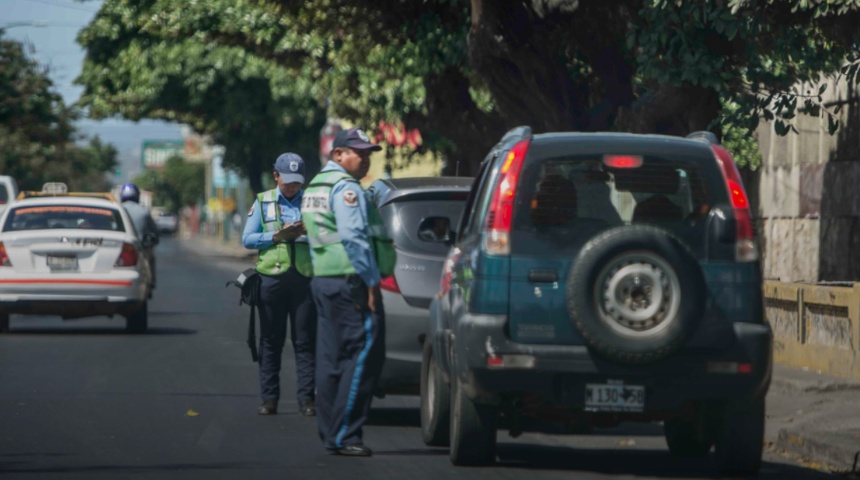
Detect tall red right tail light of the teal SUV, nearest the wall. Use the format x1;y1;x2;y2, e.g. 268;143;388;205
711;145;759;262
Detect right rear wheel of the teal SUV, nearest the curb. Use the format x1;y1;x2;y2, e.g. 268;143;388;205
716;398;765;475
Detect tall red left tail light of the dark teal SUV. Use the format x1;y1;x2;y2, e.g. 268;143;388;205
483;139;531;255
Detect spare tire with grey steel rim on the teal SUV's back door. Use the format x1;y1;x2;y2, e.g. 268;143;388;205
567;225;706;364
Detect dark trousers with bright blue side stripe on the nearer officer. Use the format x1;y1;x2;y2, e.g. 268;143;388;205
311;276;385;452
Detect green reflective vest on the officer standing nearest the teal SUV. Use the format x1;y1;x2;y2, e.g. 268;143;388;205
302;170;397;277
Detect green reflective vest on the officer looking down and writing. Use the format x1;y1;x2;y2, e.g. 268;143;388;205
257;188;313;277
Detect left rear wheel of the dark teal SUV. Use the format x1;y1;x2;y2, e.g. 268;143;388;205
450;368;498;465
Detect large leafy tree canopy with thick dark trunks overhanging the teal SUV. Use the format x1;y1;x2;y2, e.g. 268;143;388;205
74;0;860;180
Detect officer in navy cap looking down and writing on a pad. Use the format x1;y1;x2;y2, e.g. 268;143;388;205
242;153;317;416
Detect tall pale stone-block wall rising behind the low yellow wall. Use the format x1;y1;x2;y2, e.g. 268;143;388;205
747;79;860;283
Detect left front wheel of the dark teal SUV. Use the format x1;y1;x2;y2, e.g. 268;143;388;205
420;336;451;447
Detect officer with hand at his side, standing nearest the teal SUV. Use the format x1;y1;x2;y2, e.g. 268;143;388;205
302;128;395;456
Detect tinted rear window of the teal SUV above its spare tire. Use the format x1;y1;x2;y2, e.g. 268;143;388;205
511;154;724;255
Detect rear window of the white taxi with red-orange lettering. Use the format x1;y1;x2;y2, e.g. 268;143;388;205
3;205;125;232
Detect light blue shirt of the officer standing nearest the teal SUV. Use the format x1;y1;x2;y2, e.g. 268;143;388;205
311;160;379;287
